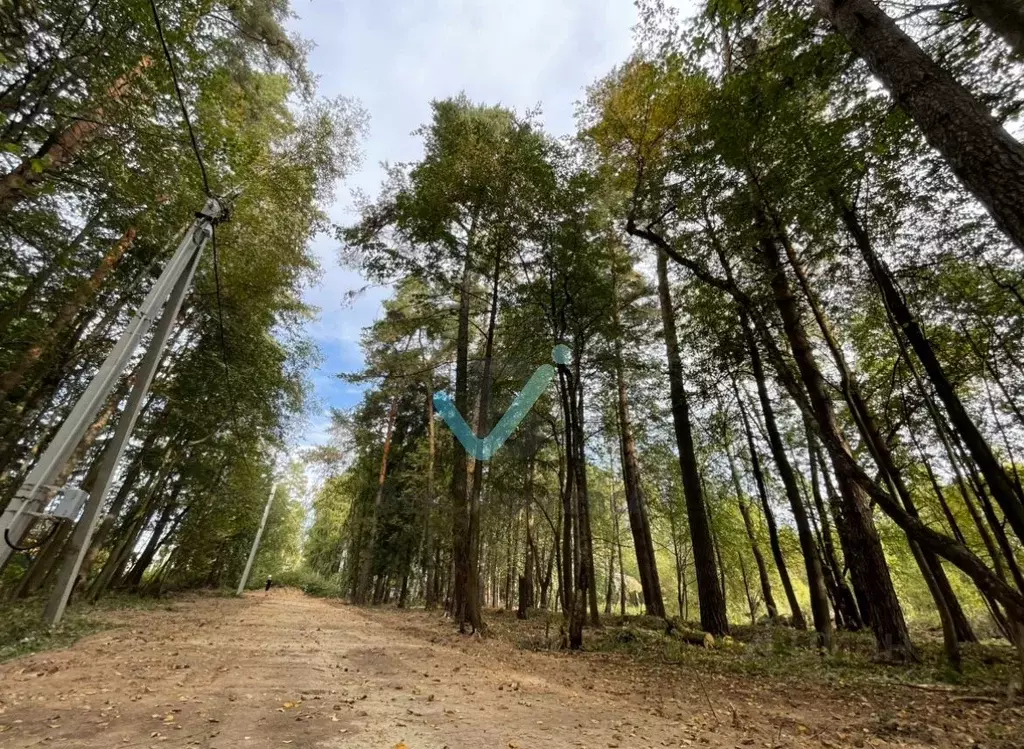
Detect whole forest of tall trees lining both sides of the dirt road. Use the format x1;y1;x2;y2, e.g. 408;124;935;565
0;0;1024;704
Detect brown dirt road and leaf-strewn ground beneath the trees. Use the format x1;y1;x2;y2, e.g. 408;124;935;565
0;589;1024;749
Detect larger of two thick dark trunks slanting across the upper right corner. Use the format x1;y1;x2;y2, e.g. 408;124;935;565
814;0;1024;249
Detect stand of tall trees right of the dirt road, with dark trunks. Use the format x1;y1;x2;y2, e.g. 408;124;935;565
304;0;1024;668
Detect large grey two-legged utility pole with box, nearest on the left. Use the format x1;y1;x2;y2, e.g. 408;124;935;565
0;193;237;625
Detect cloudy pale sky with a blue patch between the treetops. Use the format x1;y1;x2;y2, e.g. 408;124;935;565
280;0;637;446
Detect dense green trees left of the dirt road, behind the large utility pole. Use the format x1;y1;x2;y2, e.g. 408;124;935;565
0;0;366;614
